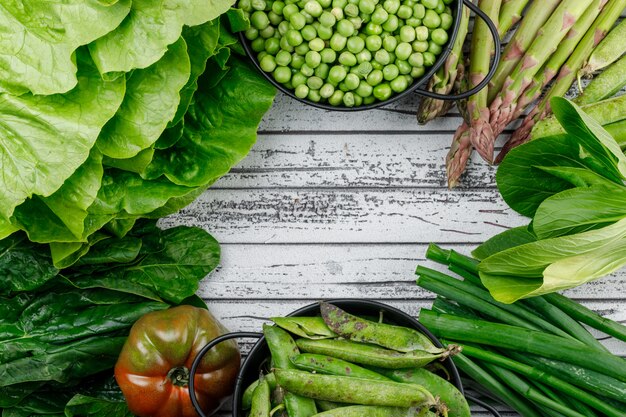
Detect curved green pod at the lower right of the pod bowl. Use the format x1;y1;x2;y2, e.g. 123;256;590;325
379;368;472;417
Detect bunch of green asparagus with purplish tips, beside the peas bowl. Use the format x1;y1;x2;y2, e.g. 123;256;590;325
418;0;626;187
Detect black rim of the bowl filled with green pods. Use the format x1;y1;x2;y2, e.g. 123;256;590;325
232;298;465;417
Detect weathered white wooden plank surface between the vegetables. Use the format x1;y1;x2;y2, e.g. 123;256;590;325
162;95;626;417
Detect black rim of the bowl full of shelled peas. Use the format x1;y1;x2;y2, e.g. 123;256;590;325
235;0;463;112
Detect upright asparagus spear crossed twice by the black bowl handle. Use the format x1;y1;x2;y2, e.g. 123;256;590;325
467;0;501;162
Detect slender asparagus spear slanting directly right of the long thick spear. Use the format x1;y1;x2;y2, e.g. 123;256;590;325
513;0;607;119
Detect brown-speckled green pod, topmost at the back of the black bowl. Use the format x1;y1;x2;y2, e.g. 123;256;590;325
320;302;445;353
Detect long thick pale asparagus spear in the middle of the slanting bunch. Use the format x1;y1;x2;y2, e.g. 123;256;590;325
489;0;592;141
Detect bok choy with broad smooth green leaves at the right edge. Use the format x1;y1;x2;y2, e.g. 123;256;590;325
474;98;626;303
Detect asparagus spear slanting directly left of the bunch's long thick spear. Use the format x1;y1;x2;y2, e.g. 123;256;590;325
487;0;560;103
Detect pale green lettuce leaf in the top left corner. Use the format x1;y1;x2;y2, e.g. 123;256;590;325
0;0;131;95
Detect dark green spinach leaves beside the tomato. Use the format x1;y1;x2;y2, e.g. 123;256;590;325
0;220;219;416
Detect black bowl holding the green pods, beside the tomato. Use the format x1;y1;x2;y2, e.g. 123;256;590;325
233;299;463;417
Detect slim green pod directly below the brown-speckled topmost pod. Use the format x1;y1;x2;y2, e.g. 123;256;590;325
296;339;456;369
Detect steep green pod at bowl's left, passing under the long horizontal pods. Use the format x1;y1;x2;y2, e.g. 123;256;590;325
263;324;317;417
